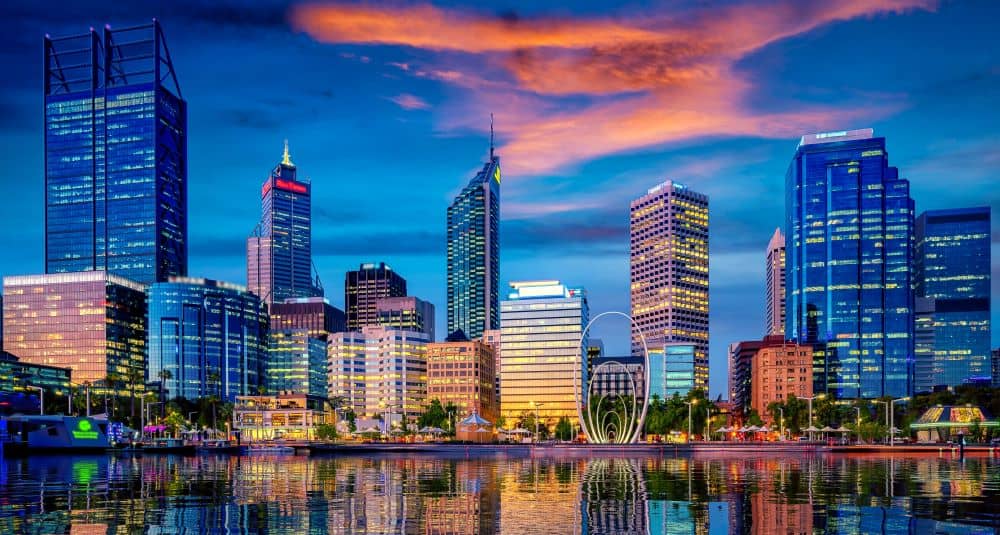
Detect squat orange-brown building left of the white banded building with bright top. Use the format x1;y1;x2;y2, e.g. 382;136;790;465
427;340;500;423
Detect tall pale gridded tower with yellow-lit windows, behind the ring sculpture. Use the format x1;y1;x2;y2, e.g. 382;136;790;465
629;180;708;390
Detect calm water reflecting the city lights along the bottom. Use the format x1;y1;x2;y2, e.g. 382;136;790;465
0;456;1000;534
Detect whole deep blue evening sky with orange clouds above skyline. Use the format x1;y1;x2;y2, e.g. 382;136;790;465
0;0;1000;396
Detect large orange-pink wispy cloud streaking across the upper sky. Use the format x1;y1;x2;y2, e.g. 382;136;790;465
291;0;936;178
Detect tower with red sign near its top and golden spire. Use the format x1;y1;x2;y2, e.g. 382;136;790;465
247;141;323;304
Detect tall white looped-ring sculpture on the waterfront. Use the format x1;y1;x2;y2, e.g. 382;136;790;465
573;311;650;444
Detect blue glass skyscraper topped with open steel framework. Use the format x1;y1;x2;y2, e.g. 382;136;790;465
43;20;188;284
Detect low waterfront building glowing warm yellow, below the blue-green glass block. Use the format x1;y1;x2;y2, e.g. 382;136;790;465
233;393;336;442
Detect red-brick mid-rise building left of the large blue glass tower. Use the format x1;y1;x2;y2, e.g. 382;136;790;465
750;342;813;423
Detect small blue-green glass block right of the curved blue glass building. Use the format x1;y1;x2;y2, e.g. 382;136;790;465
265;329;328;397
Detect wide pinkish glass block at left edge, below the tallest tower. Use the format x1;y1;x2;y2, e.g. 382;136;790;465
3;271;146;394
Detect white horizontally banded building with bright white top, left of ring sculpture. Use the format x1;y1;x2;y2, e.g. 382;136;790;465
500;281;590;427
